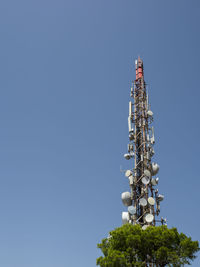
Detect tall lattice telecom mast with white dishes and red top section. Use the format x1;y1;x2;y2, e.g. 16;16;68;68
121;57;166;229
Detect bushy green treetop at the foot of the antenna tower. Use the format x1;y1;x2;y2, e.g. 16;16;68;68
97;224;199;267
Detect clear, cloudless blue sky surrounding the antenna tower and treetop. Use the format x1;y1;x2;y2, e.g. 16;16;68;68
0;0;200;267
